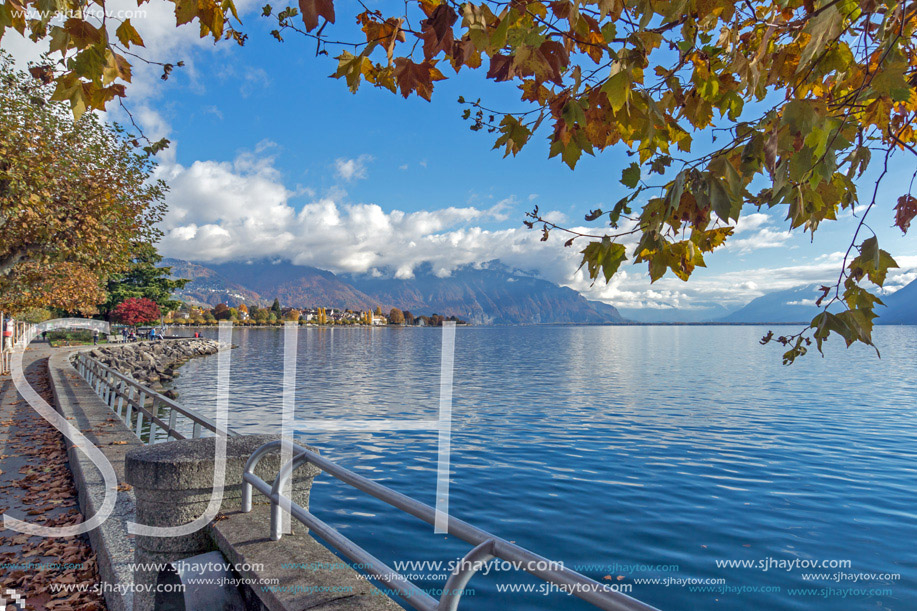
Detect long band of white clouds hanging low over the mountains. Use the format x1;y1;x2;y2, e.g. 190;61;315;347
152;141;917;317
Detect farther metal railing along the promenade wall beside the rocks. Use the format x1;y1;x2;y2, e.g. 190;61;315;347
73;352;239;444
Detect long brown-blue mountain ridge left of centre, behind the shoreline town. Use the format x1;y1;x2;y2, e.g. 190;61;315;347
162;259;626;324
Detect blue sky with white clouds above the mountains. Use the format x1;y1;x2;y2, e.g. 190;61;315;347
2;0;917;318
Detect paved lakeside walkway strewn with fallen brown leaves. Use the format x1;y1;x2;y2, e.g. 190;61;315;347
0;342;105;611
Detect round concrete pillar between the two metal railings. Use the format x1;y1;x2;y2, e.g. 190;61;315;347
125;435;320;611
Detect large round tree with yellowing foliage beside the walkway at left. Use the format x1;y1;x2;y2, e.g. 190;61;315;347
0;53;165;312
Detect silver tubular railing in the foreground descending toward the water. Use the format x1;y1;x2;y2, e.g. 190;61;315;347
242;441;655;611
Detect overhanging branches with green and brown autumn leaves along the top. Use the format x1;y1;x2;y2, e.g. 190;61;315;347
0;0;917;362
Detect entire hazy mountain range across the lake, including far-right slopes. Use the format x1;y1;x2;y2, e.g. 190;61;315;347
162;259;917;324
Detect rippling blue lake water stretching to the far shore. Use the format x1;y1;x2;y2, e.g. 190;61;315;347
168;327;917;611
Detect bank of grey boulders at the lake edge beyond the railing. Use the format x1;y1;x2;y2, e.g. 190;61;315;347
89;338;220;398
